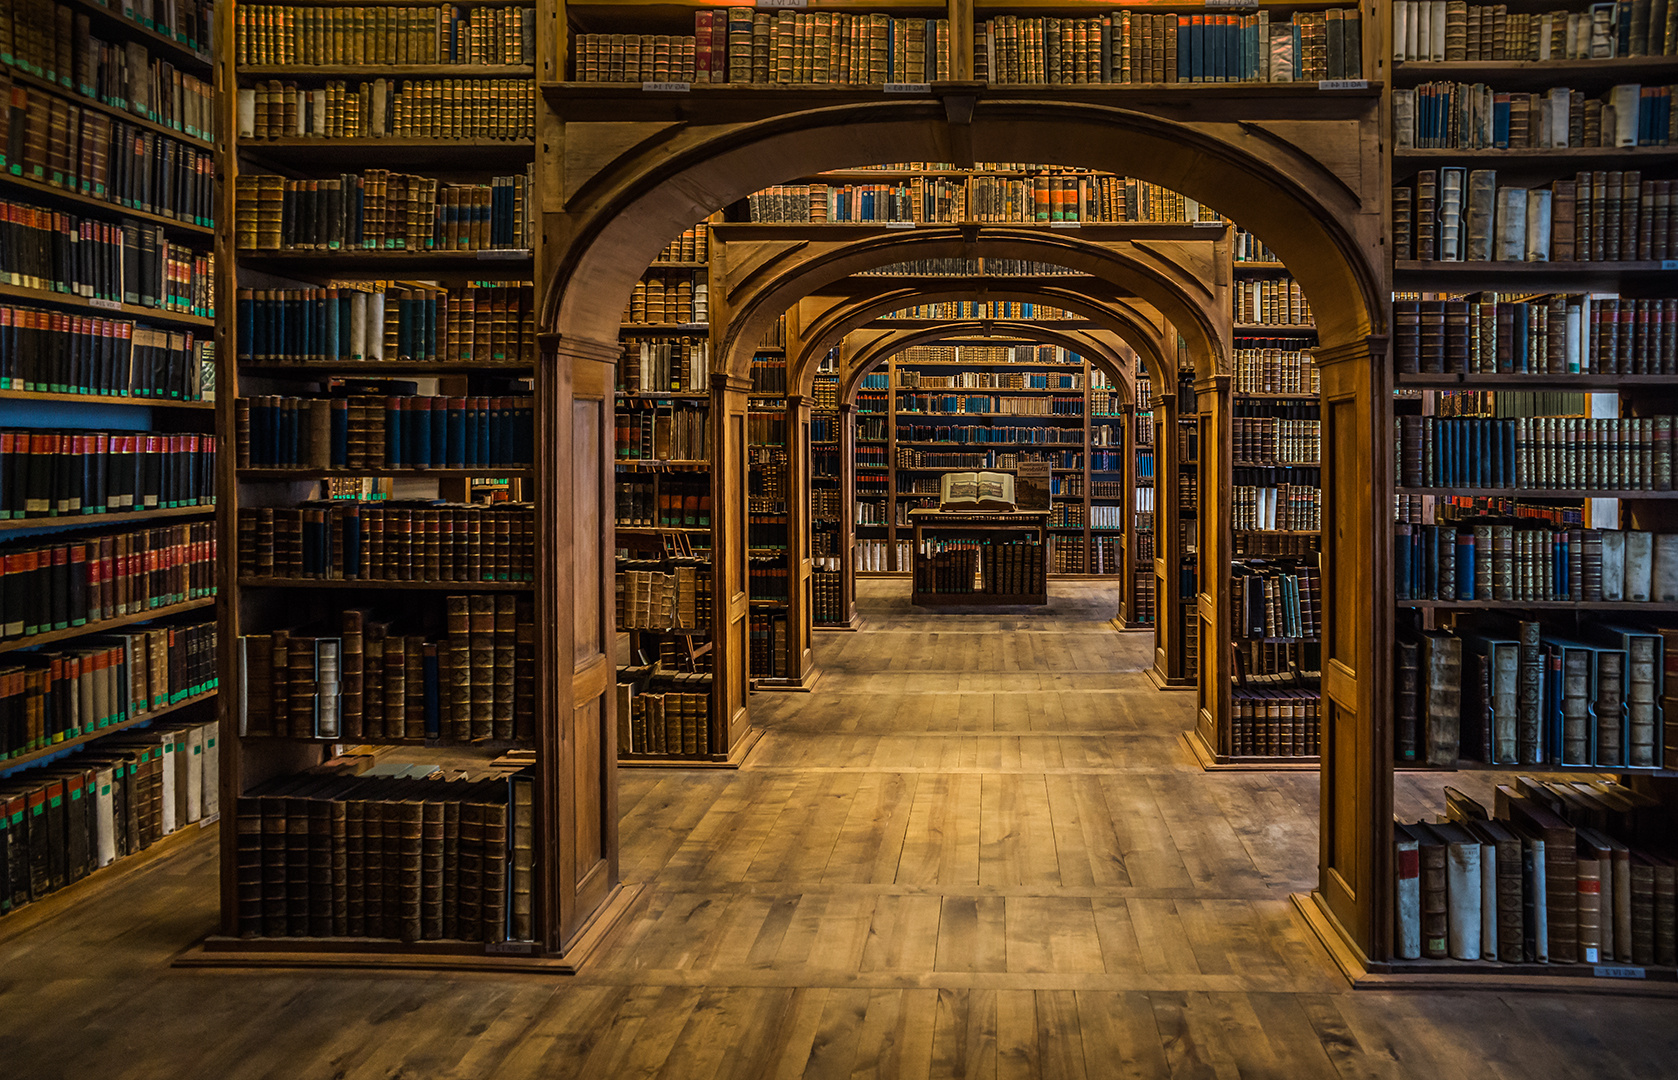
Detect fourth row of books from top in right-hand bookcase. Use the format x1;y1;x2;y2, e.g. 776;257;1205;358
1393;292;1678;376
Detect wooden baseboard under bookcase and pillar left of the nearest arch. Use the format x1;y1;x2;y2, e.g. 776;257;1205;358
171;884;643;974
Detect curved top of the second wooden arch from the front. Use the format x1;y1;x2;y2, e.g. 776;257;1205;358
711;226;1232;390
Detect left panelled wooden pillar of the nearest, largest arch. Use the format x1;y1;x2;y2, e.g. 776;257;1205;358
535;339;619;953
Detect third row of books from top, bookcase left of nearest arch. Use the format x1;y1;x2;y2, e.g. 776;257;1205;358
233;169;534;252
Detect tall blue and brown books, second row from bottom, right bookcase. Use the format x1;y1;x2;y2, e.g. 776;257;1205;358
1394;619;1678;768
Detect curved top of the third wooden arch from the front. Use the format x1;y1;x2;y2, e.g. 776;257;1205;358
787;278;1176;396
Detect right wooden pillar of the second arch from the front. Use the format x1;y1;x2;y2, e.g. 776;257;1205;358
1195;374;1233;753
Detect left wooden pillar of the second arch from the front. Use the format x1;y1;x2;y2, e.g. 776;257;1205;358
711;372;752;751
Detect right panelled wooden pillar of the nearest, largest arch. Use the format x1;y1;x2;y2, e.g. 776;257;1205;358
1316;337;1393;961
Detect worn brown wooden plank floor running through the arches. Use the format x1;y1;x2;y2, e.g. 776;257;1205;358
0;580;1678;1080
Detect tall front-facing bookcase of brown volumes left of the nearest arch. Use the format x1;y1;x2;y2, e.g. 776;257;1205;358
204;2;624;971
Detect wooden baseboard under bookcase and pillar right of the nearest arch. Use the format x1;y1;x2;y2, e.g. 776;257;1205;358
1290;892;1678;998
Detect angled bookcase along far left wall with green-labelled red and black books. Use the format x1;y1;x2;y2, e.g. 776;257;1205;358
0;0;221;919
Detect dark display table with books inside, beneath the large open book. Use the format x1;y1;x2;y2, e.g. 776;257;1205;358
909;510;1049;607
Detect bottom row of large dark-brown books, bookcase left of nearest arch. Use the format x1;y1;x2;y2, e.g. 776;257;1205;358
235;768;535;944
